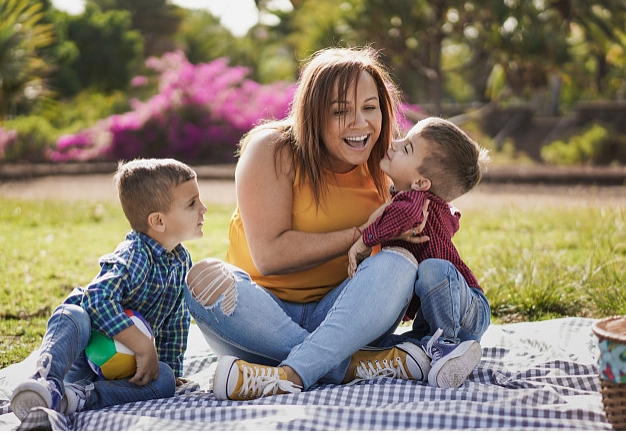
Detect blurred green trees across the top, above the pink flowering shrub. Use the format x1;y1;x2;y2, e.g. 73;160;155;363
0;0;626;164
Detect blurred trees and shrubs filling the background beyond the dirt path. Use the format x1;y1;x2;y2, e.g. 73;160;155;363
0;0;626;165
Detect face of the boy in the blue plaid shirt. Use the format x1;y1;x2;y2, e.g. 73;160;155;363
162;179;207;250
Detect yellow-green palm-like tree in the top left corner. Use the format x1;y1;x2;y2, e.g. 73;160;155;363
0;0;53;120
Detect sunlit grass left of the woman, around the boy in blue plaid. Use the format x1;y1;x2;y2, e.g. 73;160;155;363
0;199;233;368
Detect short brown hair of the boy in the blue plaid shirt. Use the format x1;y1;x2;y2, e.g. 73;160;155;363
114;159;196;233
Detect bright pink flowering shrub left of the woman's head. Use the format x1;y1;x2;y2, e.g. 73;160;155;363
50;51;293;163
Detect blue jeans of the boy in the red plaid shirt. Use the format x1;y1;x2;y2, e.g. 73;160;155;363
383;258;491;346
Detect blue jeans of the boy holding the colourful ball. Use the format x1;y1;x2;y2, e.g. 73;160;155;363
34;304;176;411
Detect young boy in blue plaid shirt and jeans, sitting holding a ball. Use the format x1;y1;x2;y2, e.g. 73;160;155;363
11;159;207;420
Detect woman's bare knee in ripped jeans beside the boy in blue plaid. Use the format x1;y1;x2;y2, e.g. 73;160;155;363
187;258;237;314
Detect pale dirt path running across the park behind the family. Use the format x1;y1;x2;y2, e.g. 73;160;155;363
0;175;626;210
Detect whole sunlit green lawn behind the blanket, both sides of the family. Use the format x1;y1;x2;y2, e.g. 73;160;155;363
0;199;626;368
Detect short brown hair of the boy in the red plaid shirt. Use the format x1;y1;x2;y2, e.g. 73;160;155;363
418;117;491;202
